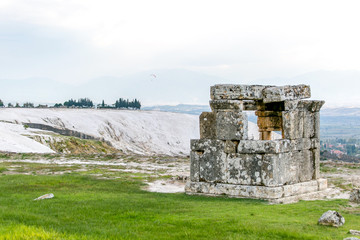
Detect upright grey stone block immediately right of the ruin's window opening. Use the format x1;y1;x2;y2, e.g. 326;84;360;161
282;110;304;140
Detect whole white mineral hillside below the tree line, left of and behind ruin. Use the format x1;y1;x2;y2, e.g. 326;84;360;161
0;108;280;155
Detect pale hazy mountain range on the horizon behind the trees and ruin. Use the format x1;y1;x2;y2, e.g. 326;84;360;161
0;69;360;108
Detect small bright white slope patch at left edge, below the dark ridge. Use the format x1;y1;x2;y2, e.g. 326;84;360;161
0;122;54;153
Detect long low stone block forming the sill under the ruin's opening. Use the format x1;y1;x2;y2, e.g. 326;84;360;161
238;139;290;153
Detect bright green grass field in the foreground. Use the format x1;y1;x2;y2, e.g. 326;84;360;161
0;169;360;239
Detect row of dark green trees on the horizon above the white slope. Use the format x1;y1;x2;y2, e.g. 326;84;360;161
0;98;141;109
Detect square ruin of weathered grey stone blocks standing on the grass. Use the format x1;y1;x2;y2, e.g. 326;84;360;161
185;85;327;203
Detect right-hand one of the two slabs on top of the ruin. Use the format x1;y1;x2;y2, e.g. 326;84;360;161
263;84;311;103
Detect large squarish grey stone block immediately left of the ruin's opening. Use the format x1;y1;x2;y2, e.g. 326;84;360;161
216;111;248;140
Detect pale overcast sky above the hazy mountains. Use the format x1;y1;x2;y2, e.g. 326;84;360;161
0;0;360;106
